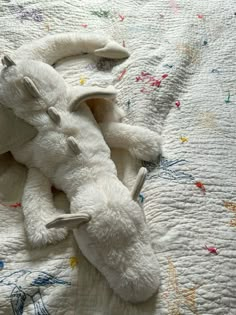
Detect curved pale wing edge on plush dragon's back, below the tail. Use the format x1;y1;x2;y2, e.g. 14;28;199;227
69;86;116;112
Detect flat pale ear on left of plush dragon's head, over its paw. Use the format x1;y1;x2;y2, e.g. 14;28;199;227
46;213;91;229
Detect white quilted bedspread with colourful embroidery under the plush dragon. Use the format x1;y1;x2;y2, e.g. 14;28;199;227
0;0;236;315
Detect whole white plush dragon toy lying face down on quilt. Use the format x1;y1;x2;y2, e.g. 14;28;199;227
0;33;160;303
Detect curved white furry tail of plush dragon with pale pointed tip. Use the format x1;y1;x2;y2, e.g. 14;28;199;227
13;32;129;65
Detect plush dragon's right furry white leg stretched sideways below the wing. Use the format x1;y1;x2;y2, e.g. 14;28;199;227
100;122;161;161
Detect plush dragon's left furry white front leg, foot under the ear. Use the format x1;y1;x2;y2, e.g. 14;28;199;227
22;168;68;247
